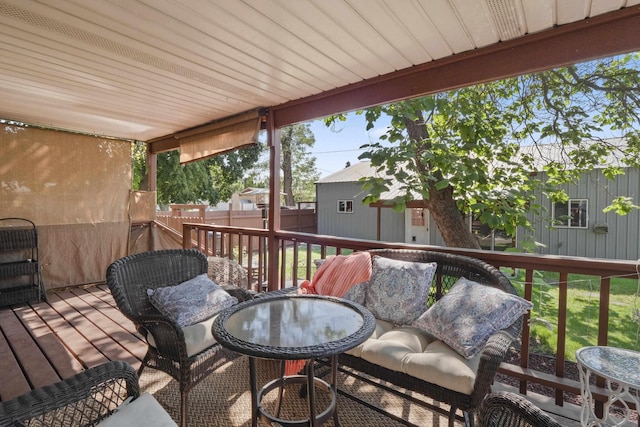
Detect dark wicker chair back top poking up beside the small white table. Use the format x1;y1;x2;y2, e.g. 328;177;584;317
478;391;562;427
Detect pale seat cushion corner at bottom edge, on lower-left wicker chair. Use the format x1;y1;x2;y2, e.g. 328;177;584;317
98;393;177;427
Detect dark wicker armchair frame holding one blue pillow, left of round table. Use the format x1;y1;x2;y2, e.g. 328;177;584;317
107;249;250;426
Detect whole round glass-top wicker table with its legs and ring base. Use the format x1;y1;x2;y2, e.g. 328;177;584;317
213;294;375;426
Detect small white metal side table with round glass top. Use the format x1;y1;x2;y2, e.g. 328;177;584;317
576;346;640;426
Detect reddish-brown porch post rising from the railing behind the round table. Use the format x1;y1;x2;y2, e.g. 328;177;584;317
267;108;280;291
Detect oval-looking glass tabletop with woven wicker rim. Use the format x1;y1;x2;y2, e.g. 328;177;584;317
213;294;375;360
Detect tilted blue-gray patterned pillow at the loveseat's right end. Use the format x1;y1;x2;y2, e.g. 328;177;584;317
413;277;533;359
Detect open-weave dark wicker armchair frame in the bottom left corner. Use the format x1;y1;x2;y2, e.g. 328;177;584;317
0;361;140;426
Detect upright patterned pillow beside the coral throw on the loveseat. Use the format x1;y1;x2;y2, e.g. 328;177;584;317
364;256;436;325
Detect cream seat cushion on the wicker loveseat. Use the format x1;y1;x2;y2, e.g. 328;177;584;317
347;320;480;394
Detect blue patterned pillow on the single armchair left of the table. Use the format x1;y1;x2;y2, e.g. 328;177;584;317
147;273;238;328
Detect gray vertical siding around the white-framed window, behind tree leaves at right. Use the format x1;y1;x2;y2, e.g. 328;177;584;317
518;168;640;260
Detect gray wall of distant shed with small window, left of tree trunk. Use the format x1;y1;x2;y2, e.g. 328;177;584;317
316;182;404;242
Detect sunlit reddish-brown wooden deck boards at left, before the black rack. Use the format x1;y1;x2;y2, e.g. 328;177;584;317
0;285;147;400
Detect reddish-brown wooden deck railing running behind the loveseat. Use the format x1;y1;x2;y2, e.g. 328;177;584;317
183;223;638;412
